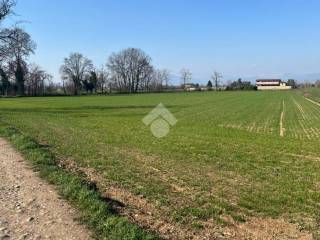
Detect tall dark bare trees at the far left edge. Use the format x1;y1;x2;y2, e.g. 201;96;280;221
0;0;52;96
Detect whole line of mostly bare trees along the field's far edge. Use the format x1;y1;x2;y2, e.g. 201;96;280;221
0;0;302;96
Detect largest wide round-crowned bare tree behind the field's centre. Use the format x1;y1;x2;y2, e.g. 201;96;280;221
107;48;153;93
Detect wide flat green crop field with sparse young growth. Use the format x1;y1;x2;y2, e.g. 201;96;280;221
0;91;320;238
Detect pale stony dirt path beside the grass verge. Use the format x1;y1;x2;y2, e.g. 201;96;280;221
0;138;91;240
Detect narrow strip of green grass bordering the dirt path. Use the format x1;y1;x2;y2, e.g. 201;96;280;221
0;124;159;240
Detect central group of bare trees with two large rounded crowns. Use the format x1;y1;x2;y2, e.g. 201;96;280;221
60;48;170;95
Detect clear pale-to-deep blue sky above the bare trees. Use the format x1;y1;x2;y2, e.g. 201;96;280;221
11;0;320;82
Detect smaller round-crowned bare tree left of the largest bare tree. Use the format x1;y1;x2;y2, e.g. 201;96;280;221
60;53;93;95
